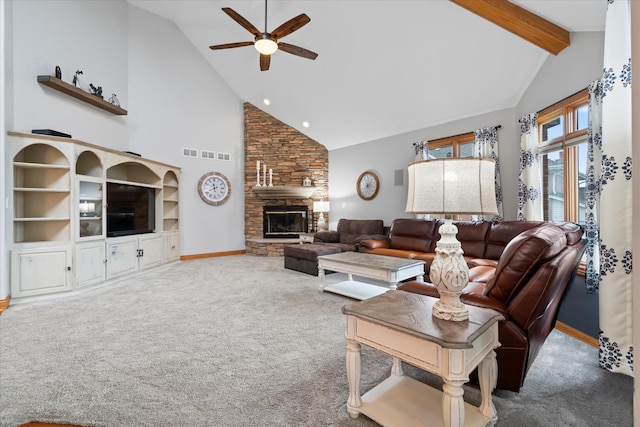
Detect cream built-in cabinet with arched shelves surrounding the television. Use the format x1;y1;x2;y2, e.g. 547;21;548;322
7;132;180;301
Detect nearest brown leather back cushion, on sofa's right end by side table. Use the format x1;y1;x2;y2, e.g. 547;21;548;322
486;224;567;304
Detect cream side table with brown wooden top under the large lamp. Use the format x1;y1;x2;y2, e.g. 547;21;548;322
342;291;502;427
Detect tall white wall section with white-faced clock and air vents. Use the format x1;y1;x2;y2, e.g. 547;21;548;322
129;7;245;255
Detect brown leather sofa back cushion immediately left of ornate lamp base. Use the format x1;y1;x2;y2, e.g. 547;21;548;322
389;218;439;252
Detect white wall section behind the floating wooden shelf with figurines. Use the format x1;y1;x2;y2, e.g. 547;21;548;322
7;0;129;150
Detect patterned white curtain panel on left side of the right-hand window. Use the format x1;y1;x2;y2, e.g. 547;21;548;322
518;113;544;221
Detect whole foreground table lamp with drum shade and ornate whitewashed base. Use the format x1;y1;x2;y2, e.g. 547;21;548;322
406;157;498;321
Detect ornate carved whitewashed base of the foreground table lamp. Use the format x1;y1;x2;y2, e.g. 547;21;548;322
429;219;469;322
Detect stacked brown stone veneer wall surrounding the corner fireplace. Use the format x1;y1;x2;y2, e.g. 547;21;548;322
244;103;329;256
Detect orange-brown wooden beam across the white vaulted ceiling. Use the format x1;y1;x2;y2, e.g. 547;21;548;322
450;0;571;55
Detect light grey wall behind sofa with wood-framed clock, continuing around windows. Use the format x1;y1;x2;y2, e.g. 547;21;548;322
329;33;604;229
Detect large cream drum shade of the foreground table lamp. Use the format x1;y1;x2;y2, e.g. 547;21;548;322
406;157;498;215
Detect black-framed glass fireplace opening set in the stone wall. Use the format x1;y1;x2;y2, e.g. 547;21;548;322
262;206;309;239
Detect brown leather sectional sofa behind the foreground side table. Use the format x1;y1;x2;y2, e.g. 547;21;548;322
360;218;586;392
